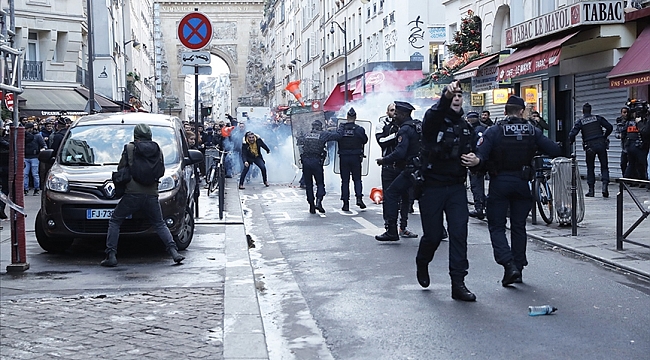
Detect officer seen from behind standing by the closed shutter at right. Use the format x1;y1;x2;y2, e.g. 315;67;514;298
569;103;614;197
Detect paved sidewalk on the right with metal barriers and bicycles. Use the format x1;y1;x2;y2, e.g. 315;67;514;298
468;179;650;279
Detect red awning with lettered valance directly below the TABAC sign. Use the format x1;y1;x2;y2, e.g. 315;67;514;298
497;32;577;81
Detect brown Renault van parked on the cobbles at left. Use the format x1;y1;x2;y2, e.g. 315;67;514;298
35;113;203;252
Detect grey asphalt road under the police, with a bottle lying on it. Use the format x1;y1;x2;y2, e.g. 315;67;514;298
241;186;650;359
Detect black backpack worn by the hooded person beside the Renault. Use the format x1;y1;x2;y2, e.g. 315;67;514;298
127;140;165;185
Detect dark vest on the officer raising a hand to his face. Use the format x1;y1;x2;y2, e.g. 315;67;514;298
420;117;474;180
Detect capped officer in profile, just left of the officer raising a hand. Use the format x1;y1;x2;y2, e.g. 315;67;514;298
375;101;422;241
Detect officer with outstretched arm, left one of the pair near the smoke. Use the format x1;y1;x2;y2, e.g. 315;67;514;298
298;120;341;214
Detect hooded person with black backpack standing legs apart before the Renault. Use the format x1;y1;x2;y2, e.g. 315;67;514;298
101;124;185;267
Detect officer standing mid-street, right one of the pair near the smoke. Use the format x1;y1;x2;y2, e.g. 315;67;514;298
337;108;368;211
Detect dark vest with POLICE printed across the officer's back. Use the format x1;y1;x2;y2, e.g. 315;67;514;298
487;118;537;173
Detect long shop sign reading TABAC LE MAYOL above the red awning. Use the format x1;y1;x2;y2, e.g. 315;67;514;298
506;0;625;47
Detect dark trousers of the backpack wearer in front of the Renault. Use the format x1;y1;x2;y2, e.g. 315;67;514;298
106;194;177;253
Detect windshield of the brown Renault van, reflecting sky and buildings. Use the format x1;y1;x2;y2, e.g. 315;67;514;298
60;124;180;166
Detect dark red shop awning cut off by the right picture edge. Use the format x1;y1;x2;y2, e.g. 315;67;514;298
607;26;650;88
